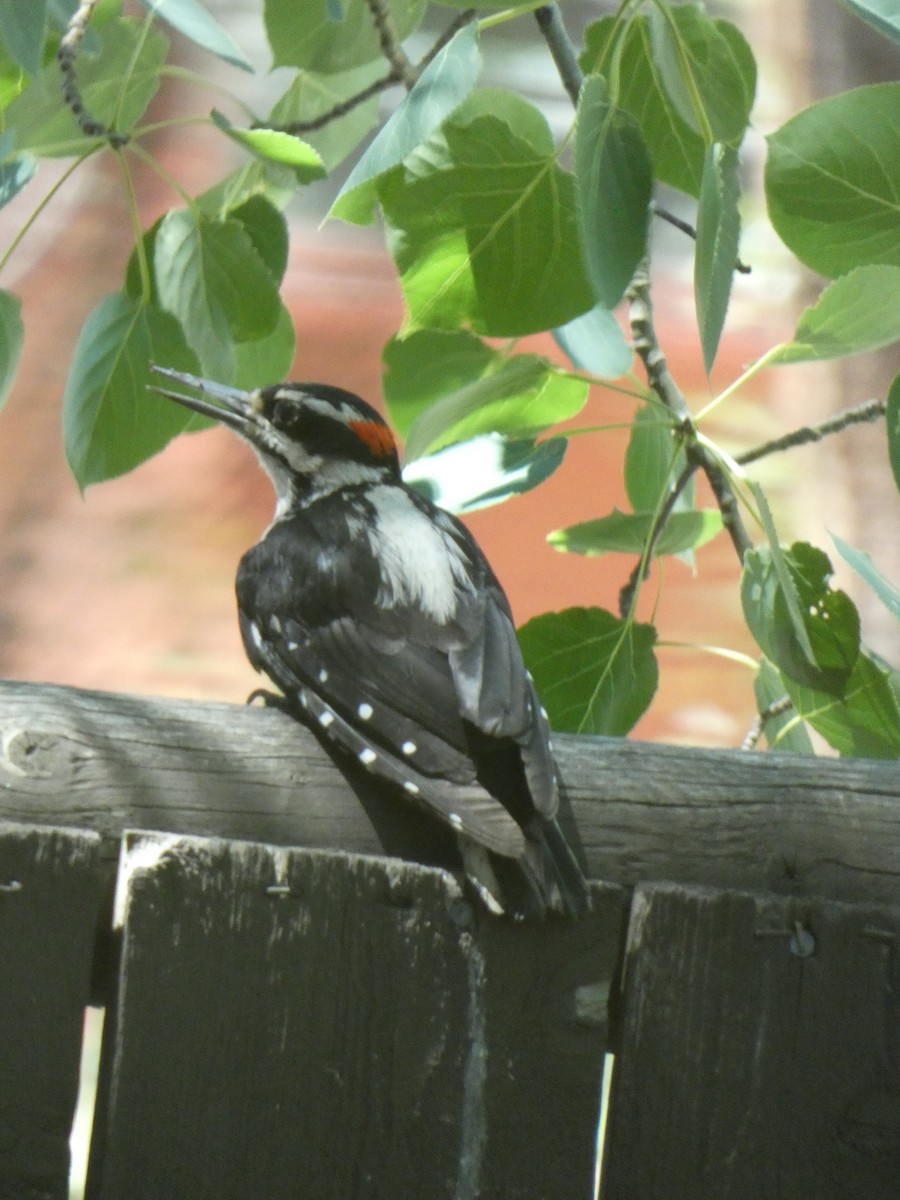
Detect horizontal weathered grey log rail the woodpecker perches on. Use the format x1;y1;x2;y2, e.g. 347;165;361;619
0;683;900;904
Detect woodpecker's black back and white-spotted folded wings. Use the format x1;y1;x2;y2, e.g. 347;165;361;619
232;482;557;858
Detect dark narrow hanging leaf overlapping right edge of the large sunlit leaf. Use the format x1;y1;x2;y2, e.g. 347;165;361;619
575;76;653;308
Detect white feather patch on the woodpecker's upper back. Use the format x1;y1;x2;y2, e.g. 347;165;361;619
367;485;472;622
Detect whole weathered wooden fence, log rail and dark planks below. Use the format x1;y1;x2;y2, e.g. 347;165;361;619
0;684;900;1200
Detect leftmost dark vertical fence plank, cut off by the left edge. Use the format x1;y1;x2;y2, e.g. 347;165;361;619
0;824;100;1200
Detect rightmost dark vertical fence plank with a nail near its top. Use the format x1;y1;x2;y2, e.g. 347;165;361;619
602;884;900;1200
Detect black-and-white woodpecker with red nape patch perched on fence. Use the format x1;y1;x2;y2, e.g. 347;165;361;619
155;367;588;916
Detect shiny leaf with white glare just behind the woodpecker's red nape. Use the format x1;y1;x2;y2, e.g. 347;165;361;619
403;433;566;512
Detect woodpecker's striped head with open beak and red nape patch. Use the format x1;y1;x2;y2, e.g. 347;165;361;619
154;367;400;512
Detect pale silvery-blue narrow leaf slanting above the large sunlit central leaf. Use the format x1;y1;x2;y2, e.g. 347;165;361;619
329;24;481;224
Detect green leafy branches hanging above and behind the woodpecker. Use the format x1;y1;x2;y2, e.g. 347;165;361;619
0;0;900;757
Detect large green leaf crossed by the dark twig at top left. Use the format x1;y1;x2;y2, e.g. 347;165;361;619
6;19;169;157
